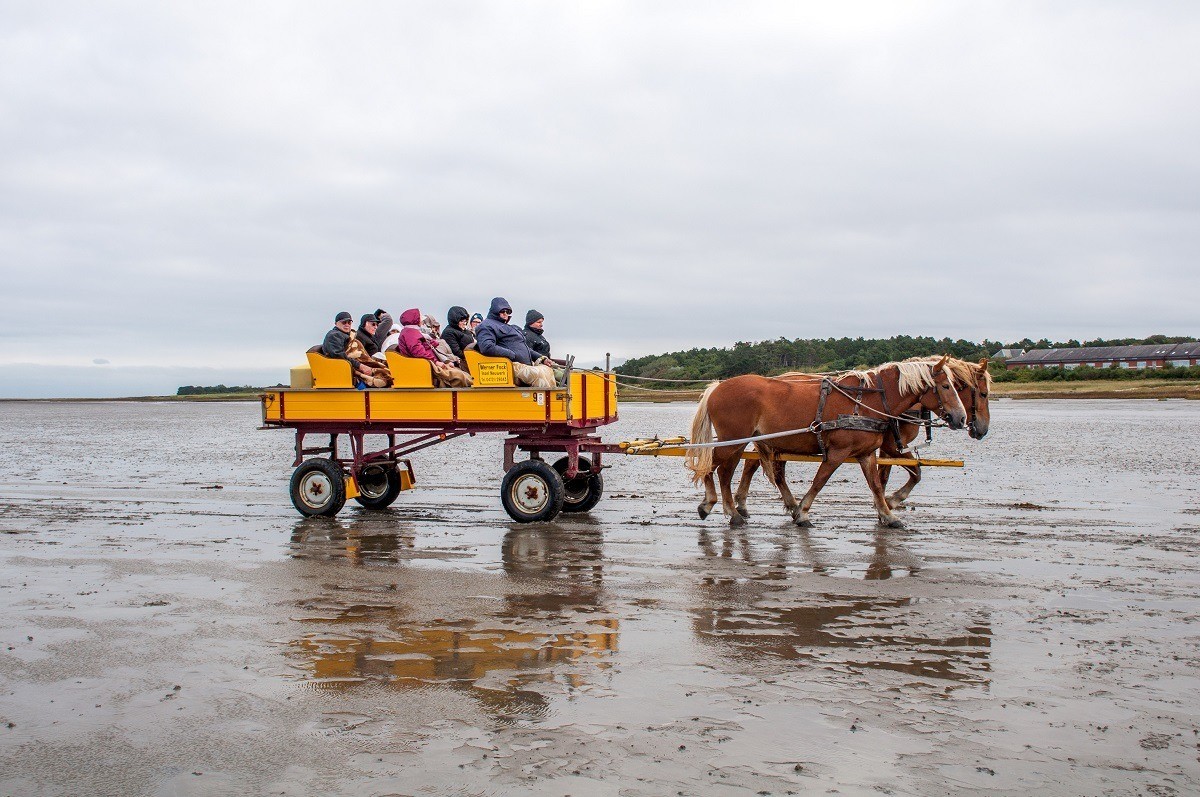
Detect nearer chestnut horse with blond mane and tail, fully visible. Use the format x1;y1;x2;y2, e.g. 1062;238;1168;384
686;358;966;528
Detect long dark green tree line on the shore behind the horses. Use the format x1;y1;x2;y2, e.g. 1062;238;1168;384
614;335;1195;386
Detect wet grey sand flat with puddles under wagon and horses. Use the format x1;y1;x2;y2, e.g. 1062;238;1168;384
0;400;1200;797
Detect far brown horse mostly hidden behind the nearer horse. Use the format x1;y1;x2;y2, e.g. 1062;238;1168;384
733;356;991;517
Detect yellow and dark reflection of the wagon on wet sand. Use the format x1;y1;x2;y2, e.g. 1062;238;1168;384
289;527;619;721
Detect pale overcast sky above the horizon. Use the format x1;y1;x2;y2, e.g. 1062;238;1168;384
0;0;1200;396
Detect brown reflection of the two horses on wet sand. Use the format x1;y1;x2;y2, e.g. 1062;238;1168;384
692;529;992;685
